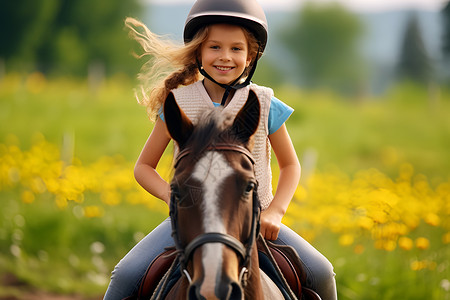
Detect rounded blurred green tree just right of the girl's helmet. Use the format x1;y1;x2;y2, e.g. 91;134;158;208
282;2;364;92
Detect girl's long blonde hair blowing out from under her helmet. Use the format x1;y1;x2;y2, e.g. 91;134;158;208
125;18;261;120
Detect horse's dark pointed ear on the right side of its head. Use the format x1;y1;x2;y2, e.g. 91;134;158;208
231;90;261;144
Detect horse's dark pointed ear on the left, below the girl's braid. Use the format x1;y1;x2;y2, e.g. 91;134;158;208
164;93;194;149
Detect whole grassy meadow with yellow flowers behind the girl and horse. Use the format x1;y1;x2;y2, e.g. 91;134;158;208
0;73;450;299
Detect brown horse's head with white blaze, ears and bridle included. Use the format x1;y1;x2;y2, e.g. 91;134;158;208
164;91;260;299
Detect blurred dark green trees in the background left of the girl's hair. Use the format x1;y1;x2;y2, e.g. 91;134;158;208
0;0;139;75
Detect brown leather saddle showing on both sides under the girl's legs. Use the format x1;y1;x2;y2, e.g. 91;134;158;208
123;239;321;300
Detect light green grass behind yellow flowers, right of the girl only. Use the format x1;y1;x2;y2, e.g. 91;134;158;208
277;82;450;178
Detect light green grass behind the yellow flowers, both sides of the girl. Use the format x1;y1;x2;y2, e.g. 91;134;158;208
0;75;450;176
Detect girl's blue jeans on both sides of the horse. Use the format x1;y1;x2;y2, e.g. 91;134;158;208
104;218;337;300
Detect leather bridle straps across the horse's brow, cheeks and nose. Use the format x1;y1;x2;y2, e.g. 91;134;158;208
170;144;261;286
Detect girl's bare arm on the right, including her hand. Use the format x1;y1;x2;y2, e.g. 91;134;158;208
261;124;300;240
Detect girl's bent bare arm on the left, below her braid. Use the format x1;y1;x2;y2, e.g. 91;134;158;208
134;118;170;204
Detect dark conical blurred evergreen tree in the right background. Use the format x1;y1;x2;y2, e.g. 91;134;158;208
397;13;432;84
